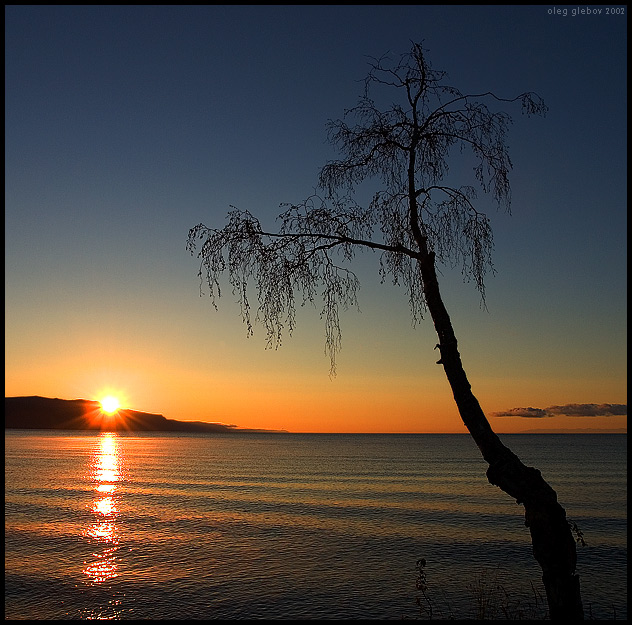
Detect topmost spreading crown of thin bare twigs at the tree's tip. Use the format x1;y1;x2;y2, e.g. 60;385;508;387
319;44;547;210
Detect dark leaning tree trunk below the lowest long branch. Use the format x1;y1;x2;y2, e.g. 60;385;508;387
419;250;584;620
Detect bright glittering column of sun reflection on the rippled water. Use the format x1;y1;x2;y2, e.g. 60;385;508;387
83;432;121;585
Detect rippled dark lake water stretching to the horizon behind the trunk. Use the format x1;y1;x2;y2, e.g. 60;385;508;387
5;430;627;620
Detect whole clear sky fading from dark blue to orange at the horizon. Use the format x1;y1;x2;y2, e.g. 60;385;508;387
5;5;627;432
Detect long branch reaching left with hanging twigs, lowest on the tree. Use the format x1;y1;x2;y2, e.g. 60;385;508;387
187;196;416;374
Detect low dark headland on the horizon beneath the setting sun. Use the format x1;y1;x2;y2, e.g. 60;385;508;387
4;396;282;433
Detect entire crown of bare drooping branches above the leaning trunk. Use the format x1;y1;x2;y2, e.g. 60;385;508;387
188;44;546;371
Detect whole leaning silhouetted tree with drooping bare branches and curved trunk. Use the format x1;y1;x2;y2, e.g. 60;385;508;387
187;43;583;619
